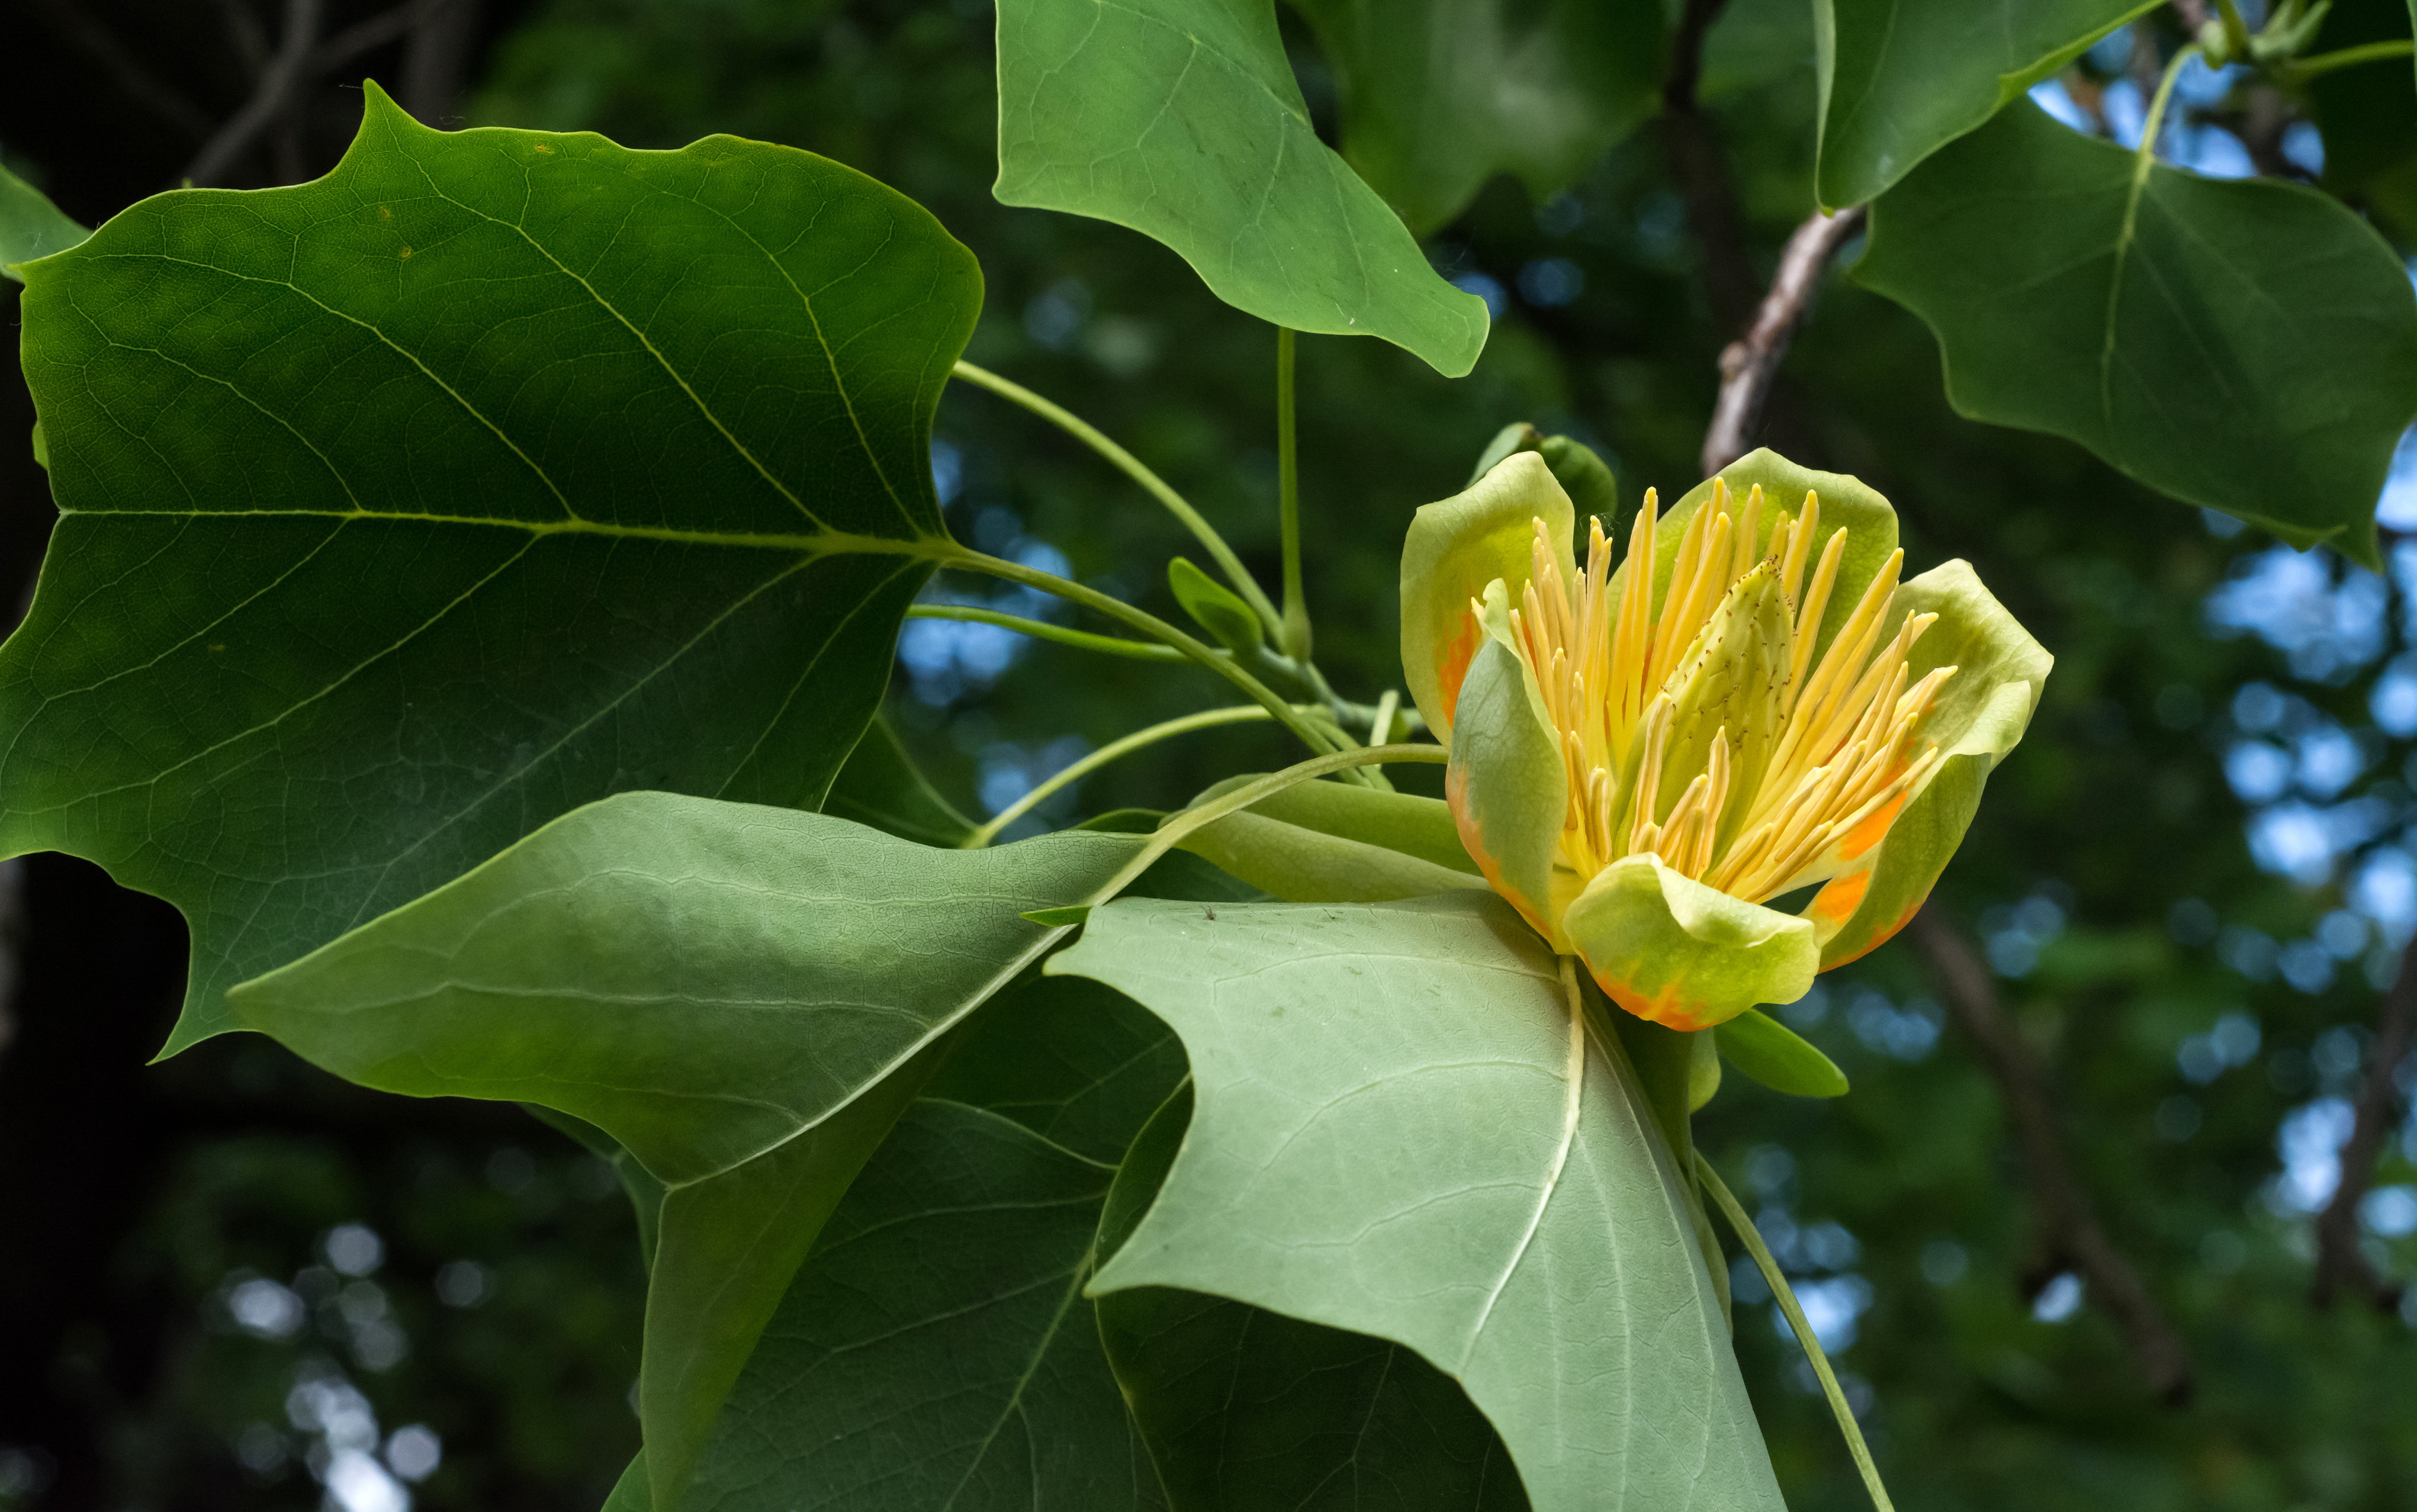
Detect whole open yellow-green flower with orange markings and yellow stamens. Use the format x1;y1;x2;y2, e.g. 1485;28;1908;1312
1402;452;2052;1029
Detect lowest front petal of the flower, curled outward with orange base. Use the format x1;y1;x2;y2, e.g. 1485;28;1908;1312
1561;852;1820;1029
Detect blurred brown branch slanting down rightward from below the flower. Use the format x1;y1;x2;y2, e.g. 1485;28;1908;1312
1907;903;2190;1405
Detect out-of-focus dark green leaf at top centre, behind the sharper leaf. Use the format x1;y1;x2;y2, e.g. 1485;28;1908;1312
1293;0;1663;237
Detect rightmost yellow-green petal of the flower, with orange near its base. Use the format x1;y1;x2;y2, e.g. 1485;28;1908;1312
1805;561;2057;971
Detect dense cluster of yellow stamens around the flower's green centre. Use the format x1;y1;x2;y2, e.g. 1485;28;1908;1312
1510;483;1955;903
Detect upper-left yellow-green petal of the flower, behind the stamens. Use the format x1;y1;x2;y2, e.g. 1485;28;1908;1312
1402;452;1576;744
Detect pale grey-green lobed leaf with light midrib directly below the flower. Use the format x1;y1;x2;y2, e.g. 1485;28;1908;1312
1049;894;1781;1510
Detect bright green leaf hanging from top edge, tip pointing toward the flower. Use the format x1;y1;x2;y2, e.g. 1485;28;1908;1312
994;0;1486;377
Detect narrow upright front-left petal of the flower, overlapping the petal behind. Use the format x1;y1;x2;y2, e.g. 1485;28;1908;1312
1443;618;1569;949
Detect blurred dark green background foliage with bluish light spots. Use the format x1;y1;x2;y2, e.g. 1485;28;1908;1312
14;0;2417;1512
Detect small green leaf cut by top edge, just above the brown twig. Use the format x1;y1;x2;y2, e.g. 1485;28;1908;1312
1813;0;2161;208
